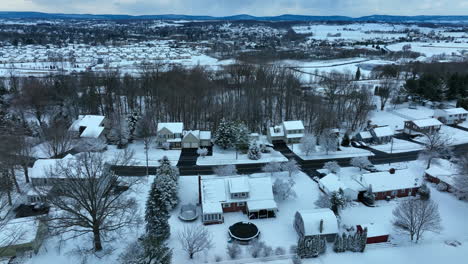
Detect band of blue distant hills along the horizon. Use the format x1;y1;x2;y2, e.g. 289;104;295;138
0;12;468;22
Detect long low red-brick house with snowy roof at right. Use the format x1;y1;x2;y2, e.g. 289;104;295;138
356;169;422;200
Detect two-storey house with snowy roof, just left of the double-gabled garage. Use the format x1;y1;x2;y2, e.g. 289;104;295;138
156;122;184;149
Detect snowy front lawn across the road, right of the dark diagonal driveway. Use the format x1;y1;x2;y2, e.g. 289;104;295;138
288;143;374;160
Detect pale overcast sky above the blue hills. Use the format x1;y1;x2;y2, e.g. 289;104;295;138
0;0;468;17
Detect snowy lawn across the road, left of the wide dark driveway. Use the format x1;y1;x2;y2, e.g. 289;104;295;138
104;140;181;166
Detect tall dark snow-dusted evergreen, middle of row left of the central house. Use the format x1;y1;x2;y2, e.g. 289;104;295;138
145;176;171;240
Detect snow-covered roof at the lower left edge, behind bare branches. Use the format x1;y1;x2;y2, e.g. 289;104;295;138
0;217;39;247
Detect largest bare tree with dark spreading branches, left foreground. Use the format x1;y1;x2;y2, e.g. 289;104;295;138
39;151;139;251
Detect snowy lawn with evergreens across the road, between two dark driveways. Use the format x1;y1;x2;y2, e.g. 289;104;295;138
197;145;288;165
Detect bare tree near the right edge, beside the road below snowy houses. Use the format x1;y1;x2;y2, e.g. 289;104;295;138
420;131;452;169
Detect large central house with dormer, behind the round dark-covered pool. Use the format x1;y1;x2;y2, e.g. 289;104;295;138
198;176;278;224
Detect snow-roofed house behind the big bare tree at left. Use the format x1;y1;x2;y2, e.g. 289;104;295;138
29;154;75;187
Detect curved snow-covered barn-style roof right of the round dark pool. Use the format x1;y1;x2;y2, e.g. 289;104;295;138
297;208;338;236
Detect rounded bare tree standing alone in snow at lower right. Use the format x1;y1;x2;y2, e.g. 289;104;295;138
393;198;442;242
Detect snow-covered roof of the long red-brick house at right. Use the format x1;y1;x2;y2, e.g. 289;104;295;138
358;169;422;192
